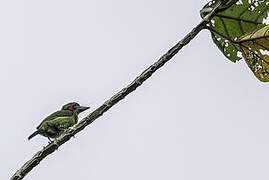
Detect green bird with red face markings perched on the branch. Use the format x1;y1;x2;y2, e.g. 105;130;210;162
28;102;90;142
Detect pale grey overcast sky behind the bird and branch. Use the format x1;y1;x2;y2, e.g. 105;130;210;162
0;0;269;180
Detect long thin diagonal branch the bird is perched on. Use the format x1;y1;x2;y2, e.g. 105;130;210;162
11;3;220;180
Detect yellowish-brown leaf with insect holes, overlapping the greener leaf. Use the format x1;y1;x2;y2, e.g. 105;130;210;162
238;25;269;82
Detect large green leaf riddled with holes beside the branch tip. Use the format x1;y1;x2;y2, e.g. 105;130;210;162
201;0;269;62
